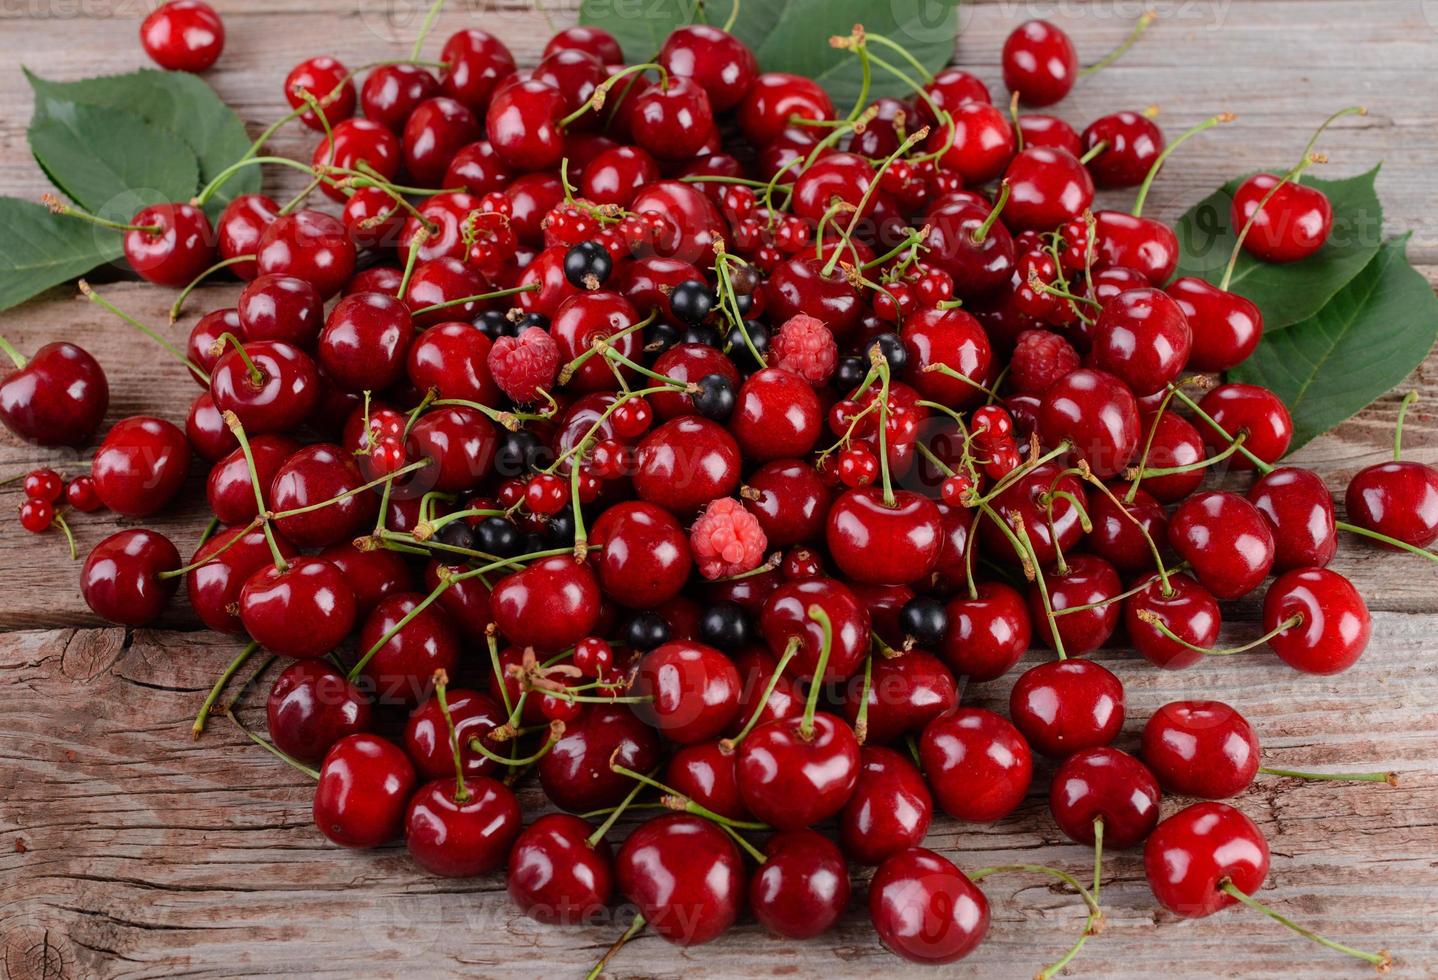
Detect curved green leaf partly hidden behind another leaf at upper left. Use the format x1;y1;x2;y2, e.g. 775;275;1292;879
24;69;260;216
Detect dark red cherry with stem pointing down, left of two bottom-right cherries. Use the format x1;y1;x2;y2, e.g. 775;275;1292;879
1048;747;1162;851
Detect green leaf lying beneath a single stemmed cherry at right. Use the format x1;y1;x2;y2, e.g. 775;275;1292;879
1178;167;1383;332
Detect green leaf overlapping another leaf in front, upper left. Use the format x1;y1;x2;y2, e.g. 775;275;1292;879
29;96;200;221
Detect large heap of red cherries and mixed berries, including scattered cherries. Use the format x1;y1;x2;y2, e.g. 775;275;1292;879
0;3;1438;976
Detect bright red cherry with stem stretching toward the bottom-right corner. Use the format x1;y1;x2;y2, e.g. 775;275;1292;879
1143;803;1268;918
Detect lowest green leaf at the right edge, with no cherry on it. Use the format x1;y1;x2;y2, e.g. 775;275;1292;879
1228;233;1438;450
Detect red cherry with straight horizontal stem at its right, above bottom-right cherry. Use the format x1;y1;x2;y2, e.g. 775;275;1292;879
1142;701;1258;799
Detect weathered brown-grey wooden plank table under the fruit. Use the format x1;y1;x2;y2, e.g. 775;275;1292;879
0;0;1438;980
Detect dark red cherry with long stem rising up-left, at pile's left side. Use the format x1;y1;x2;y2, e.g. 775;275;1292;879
240;558;355;660
